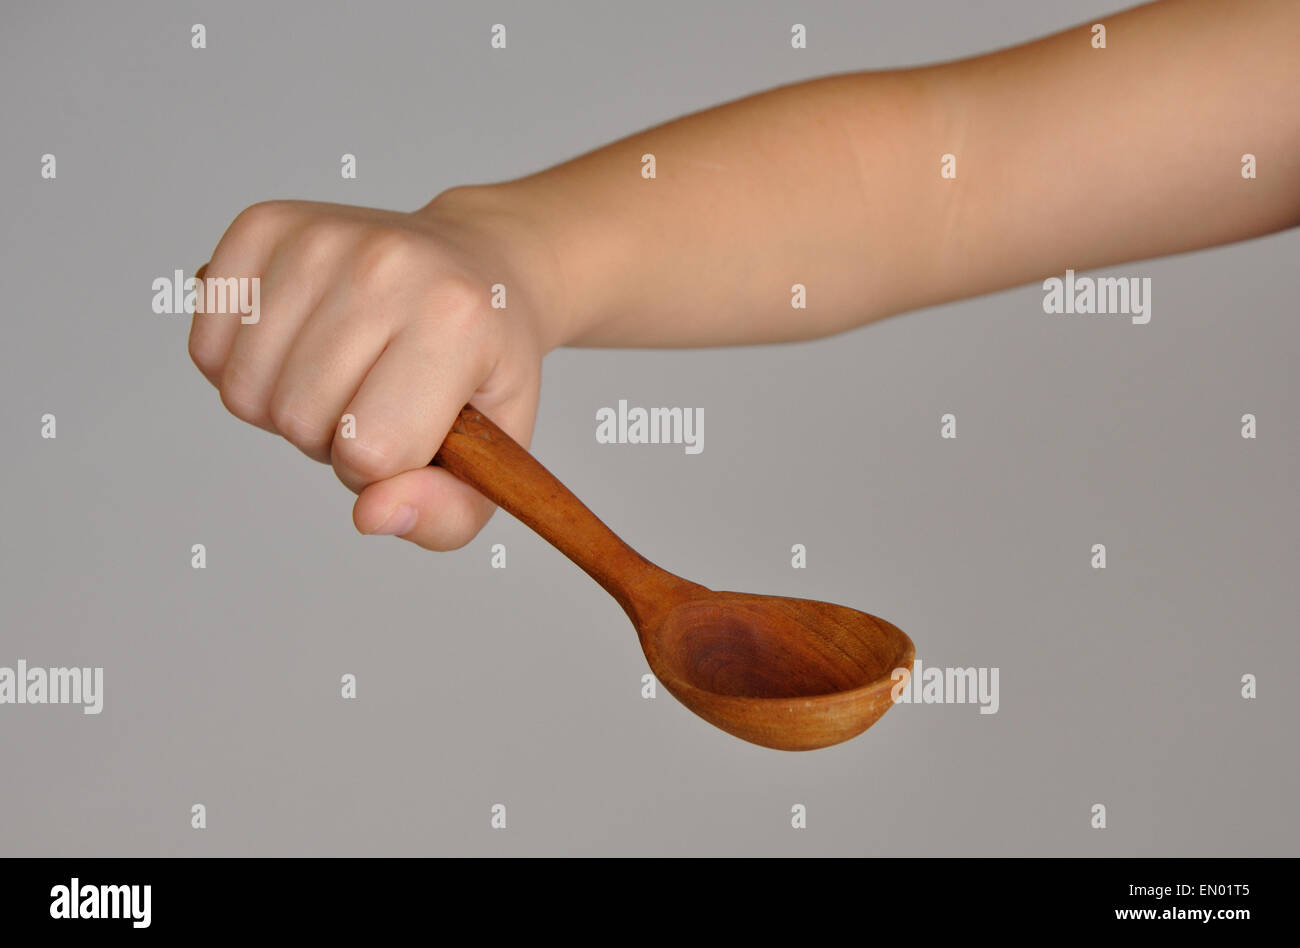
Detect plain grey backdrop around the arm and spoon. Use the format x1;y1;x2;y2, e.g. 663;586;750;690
0;0;1300;856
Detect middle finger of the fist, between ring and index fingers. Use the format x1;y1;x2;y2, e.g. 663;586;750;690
269;280;390;463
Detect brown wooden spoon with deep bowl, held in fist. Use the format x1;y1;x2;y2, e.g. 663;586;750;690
432;406;915;750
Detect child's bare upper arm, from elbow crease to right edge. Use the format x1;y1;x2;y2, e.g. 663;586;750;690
920;0;1300;314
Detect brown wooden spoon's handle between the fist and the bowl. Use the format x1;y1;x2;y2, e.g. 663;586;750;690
430;404;697;628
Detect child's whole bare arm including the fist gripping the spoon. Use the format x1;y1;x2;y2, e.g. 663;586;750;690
190;0;1300;550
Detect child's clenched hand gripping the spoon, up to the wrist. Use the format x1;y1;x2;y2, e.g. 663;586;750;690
190;189;555;550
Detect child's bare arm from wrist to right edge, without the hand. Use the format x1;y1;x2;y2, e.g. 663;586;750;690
439;0;1300;346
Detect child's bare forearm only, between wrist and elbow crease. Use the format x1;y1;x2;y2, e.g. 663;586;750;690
439;73;944;346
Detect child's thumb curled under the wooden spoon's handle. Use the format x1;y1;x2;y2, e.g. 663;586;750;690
352;380;537;551
